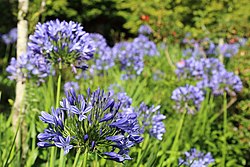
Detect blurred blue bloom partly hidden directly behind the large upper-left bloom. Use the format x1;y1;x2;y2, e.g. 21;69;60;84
89;33;115;72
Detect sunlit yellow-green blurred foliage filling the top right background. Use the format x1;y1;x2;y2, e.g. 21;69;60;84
116;0;250;42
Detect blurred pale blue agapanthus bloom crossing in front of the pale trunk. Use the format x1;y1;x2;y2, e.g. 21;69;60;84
6;52;54;83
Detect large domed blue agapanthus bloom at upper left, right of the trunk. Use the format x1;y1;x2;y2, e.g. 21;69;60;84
28;19;95;73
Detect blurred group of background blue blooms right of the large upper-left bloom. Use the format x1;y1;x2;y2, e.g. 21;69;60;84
78;25;159;80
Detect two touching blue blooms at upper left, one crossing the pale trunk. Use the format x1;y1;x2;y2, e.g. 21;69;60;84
7;20;95;81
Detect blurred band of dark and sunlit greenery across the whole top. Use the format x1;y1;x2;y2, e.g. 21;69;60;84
0;0;250;45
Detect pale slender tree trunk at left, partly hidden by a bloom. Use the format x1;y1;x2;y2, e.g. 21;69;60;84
12;0;29;160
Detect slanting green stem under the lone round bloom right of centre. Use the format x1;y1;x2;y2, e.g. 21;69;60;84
168;110;187;167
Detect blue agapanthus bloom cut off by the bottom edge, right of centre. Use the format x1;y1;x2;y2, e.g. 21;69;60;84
179;148;214;167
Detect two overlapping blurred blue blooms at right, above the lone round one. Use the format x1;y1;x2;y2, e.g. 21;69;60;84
176;57;243;95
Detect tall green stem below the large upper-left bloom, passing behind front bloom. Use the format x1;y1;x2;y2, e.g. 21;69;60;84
50;62;64;167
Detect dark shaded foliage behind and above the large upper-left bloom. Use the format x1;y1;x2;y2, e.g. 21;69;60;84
43;0;126;45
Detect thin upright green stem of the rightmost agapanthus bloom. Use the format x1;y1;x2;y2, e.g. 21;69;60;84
221;92;227;167
